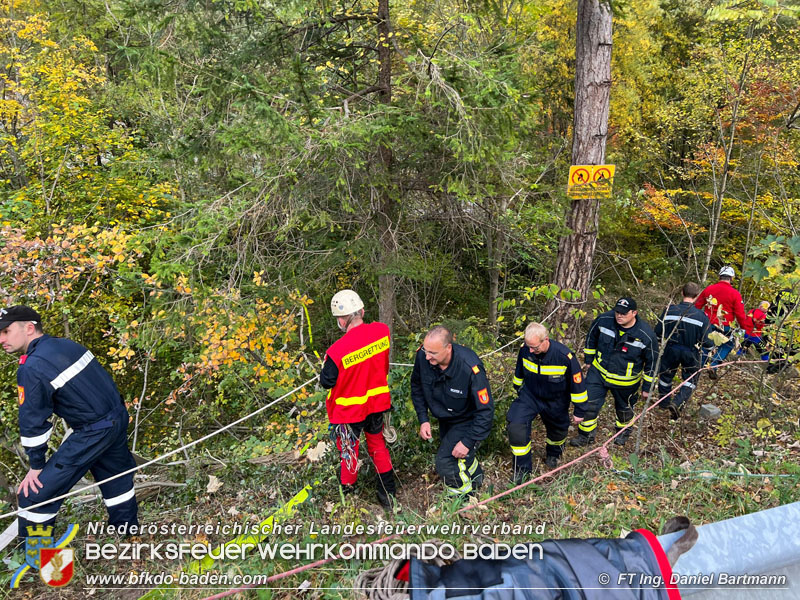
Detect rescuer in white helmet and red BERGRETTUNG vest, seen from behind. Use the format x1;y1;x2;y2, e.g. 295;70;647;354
319;290;396;510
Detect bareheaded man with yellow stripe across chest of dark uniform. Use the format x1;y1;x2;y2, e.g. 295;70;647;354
506;323;588;483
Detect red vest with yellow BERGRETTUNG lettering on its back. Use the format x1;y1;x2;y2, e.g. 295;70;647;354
326;322;392;424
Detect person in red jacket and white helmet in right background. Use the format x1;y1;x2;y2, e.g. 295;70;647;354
694;266;751;379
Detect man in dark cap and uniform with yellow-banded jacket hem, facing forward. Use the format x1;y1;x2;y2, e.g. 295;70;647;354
569;298;657;446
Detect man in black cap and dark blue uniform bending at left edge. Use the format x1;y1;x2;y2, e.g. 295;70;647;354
0;306;138;537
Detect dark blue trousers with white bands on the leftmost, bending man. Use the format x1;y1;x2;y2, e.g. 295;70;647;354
17;409;139;537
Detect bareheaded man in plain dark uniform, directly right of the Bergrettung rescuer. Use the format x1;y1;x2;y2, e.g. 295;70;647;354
411;325;494;496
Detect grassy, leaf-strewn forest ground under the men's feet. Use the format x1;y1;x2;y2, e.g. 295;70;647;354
5;354;800;600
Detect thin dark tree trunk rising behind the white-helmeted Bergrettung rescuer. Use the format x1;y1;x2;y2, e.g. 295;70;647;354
377;0;397;350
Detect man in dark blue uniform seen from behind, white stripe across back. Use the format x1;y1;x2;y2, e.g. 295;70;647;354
656;282;714;419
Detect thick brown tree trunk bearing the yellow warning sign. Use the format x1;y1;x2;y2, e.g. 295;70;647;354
546;0;612;345
